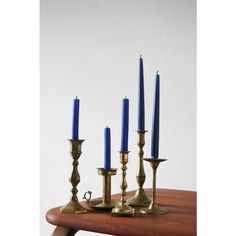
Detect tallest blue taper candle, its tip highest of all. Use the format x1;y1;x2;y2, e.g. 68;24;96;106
138;55;145;131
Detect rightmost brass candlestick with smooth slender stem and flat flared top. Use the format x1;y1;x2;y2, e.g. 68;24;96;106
141;158;167;215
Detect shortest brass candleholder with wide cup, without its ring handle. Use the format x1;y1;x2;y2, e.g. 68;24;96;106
93;168;117;209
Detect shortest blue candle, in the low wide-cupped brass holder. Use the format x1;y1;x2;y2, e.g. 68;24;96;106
104;127;111;170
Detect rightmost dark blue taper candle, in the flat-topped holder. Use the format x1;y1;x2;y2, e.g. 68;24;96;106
151;72;160;159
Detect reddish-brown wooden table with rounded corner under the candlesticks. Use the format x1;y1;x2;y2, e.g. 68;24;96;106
46;189;196;236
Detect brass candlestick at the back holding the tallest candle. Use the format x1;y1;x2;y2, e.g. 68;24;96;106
127;130;151;206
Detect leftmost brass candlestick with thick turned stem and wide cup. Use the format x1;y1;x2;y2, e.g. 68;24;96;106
60;139;87;213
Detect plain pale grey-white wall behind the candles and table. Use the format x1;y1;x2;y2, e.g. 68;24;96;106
40;0;196;235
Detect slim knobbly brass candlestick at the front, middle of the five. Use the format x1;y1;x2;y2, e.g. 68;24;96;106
111;151;135;216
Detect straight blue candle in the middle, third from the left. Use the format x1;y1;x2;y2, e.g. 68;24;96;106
121;98;129;152
